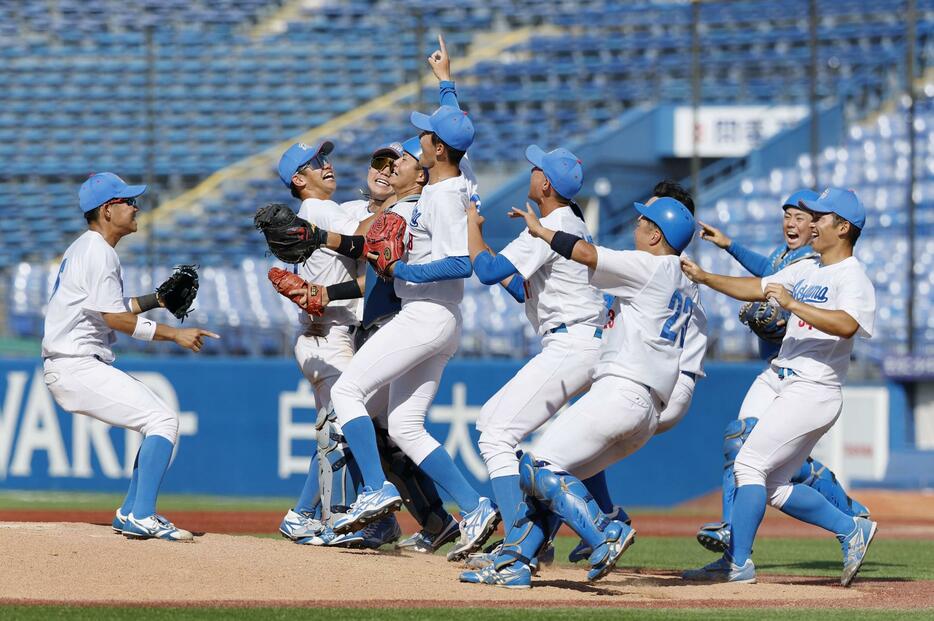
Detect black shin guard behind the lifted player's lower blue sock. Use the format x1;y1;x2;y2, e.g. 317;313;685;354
376;427;449;535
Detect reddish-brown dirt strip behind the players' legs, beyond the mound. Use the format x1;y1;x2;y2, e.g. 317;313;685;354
0;491;934;539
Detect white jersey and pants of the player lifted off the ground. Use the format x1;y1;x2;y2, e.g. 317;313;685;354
332;175;468;464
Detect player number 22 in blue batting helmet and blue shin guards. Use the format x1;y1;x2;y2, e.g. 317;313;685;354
460;197;698;588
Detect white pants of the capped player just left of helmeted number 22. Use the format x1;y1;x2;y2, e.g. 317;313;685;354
477;325;600;478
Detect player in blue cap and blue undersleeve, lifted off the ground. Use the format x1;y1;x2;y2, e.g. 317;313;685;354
333;76;498;555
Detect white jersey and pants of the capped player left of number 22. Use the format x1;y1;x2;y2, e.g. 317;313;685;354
477;207;606;478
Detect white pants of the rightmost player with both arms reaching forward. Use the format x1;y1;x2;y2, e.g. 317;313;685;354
733;367;843;509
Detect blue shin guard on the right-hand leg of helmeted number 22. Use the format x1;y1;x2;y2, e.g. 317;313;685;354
519;452;610;549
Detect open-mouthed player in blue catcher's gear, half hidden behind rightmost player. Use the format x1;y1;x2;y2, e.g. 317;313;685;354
697;190;869;553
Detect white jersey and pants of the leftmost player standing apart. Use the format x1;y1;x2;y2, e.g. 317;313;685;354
42;231;178;444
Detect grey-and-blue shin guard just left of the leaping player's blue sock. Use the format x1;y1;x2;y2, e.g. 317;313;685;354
315;407;363;525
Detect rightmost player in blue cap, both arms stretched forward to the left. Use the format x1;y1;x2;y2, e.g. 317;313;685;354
682;188;877;586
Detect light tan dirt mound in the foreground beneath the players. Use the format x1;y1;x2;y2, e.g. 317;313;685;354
0;522;934;609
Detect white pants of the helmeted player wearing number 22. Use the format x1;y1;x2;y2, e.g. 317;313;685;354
532;375;661;480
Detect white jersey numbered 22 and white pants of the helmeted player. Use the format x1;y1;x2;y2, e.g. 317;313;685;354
534;246;699;479
